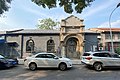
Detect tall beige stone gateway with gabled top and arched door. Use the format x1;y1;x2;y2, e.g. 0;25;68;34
60;15;85;59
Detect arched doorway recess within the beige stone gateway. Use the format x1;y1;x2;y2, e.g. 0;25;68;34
66;37;79;58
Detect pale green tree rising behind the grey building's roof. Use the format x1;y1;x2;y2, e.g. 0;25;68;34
37;18;59;29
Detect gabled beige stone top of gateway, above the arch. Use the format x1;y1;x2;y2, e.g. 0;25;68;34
61;15;85;34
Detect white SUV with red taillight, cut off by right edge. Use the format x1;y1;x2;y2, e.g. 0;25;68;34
81;51;120;71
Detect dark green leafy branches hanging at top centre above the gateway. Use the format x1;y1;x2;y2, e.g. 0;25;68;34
32;0;95;13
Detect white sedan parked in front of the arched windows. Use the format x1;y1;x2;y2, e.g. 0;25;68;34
24;53;72;71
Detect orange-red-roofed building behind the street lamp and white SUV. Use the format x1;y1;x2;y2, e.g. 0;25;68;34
89;28;120;51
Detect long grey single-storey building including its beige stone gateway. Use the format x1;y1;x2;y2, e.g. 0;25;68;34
0;15;99;59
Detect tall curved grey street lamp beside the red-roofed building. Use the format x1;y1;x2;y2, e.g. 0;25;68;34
109;3;120;53
